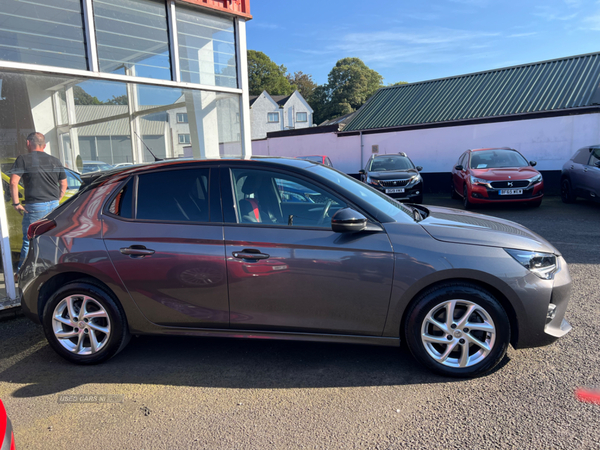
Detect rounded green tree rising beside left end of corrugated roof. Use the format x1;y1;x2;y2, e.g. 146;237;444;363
326;58;383;119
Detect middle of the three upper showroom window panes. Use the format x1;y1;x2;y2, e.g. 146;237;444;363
94;0;171;80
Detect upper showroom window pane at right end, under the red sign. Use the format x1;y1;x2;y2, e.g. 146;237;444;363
176;7;238;88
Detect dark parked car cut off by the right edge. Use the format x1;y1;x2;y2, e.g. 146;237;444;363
560;145;600;203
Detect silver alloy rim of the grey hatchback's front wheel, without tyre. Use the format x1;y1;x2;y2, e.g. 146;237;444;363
421;300;496;368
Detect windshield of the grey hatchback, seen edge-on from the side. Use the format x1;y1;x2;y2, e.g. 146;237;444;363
310;165;413;221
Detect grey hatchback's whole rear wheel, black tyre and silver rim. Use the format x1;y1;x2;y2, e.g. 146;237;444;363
42;280;130;364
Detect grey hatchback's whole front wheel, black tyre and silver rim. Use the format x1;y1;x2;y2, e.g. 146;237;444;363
403;282;510;377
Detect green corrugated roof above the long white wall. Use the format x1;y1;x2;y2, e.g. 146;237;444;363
344;53;600;132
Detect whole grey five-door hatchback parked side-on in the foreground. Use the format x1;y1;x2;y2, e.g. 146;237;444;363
19;158;571;377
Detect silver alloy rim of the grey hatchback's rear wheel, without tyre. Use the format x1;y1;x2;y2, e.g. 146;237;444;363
52;295;110;355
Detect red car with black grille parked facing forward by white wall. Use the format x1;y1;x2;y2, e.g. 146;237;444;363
451;148;544;209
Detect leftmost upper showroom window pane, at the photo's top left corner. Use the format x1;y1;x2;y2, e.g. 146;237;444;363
0;0;87;70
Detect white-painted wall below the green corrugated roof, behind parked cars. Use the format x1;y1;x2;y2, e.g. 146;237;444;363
252;114;600;173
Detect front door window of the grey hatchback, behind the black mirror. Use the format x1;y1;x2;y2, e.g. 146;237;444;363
232;169;346;229
